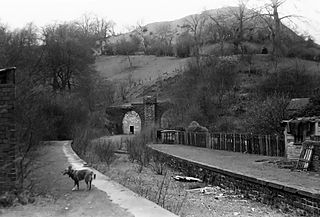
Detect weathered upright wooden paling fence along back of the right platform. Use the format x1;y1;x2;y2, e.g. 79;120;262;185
161;130;285;156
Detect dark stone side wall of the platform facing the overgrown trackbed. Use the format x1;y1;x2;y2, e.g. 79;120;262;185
152;150;320;216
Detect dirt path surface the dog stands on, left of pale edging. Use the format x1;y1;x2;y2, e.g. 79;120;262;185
0;142;133;217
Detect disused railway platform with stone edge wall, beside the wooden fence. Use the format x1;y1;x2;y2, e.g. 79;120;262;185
149;144;320;216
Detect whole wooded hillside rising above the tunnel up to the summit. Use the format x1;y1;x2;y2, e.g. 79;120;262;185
95;7;320;134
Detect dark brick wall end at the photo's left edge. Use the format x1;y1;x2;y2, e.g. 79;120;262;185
0;68;17;193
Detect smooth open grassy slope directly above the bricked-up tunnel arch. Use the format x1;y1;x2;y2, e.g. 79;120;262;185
95;55;188;101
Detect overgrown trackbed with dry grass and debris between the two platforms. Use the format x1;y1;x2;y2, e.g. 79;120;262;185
95;155;299;217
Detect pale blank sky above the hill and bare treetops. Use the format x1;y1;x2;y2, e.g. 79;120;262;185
0;0;320;43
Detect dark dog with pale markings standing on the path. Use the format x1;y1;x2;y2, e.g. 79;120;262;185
63;166;96;191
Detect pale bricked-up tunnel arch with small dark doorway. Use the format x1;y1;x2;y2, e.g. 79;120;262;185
122;111;141;134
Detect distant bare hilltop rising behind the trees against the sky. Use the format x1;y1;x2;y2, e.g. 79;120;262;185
107;7;301;48
